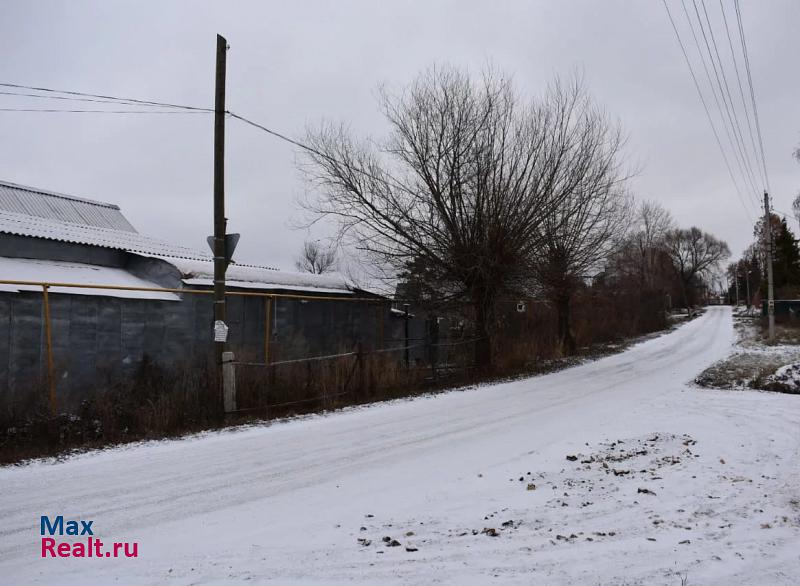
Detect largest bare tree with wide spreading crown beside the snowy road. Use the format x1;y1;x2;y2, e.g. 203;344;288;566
305;67;632;367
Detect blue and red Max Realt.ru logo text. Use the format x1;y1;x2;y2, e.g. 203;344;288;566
40;515;139;558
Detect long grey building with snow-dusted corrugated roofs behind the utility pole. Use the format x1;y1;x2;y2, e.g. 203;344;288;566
0;182;396;403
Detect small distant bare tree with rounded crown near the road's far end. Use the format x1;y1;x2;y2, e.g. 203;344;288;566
664;227;731;311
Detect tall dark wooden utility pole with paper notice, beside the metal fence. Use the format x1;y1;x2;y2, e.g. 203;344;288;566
214;35;228;390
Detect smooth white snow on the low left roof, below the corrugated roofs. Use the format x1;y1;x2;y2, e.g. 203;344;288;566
0;257;180;301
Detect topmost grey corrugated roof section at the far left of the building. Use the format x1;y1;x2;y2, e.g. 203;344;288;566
0;181;136;232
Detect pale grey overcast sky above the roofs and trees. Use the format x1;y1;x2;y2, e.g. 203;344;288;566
0;0;800;268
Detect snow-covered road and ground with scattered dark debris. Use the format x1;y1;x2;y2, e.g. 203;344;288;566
0;307;800;585
